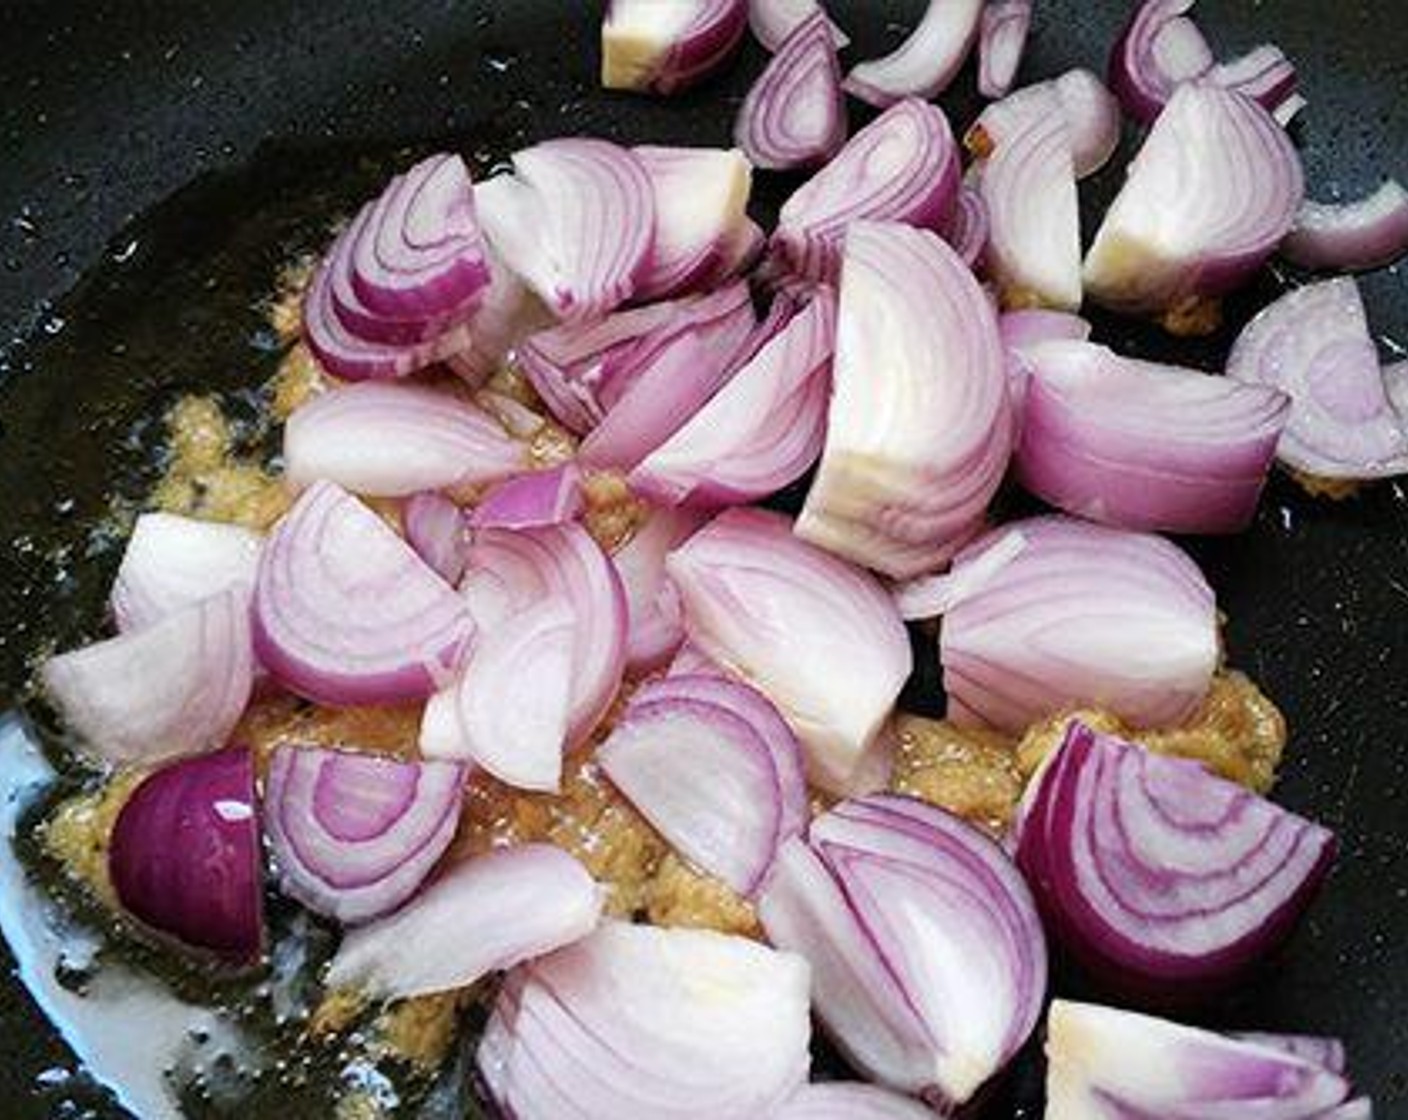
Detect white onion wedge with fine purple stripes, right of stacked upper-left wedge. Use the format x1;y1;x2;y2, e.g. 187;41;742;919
474;138;655;323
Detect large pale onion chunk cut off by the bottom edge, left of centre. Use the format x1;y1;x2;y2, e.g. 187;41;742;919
479;921;811;1120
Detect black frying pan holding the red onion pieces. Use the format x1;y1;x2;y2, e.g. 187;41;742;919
0;0;1408;1120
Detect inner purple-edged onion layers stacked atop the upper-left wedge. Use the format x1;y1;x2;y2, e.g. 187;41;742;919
351;154;489;324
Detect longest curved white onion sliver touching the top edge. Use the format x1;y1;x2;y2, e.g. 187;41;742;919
846;0;983;108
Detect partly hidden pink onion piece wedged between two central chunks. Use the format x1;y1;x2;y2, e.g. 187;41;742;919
611;506;704;675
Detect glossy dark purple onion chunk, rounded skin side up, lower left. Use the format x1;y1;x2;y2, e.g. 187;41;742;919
107;748;263;968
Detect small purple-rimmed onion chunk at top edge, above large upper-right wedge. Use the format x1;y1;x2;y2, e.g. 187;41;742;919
1110;0;1212;124
